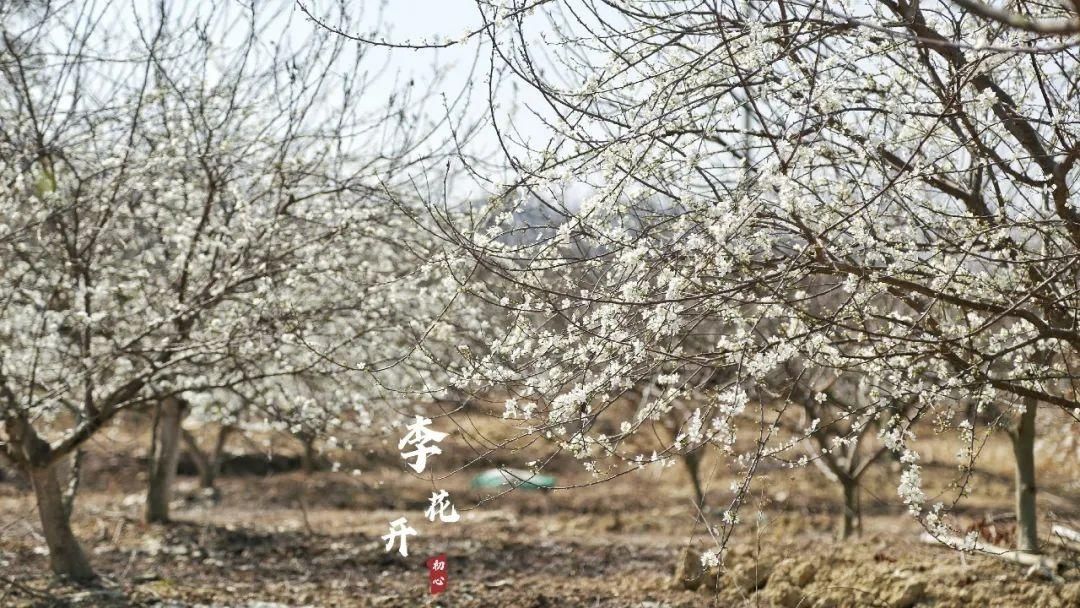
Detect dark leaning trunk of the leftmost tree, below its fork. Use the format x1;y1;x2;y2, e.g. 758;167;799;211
27;464;97;583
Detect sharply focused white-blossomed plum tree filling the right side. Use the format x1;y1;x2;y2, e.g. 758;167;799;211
313;0;1080;552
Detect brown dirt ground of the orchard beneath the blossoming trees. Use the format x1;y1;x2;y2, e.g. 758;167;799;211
0;416;1080;608
